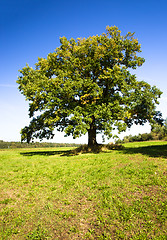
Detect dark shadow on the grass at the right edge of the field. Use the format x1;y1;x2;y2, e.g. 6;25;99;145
122;144;167;158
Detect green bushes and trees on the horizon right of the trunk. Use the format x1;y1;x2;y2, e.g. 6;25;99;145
117;119;167;143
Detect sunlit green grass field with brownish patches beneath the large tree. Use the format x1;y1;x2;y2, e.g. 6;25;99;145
0;142;167;240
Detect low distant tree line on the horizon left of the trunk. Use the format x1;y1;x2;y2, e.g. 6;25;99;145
0;140;81;149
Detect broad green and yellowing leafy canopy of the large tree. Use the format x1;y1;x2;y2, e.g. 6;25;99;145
17;26;162;142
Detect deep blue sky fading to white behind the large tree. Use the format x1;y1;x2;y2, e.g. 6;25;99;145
0;0;167;143
